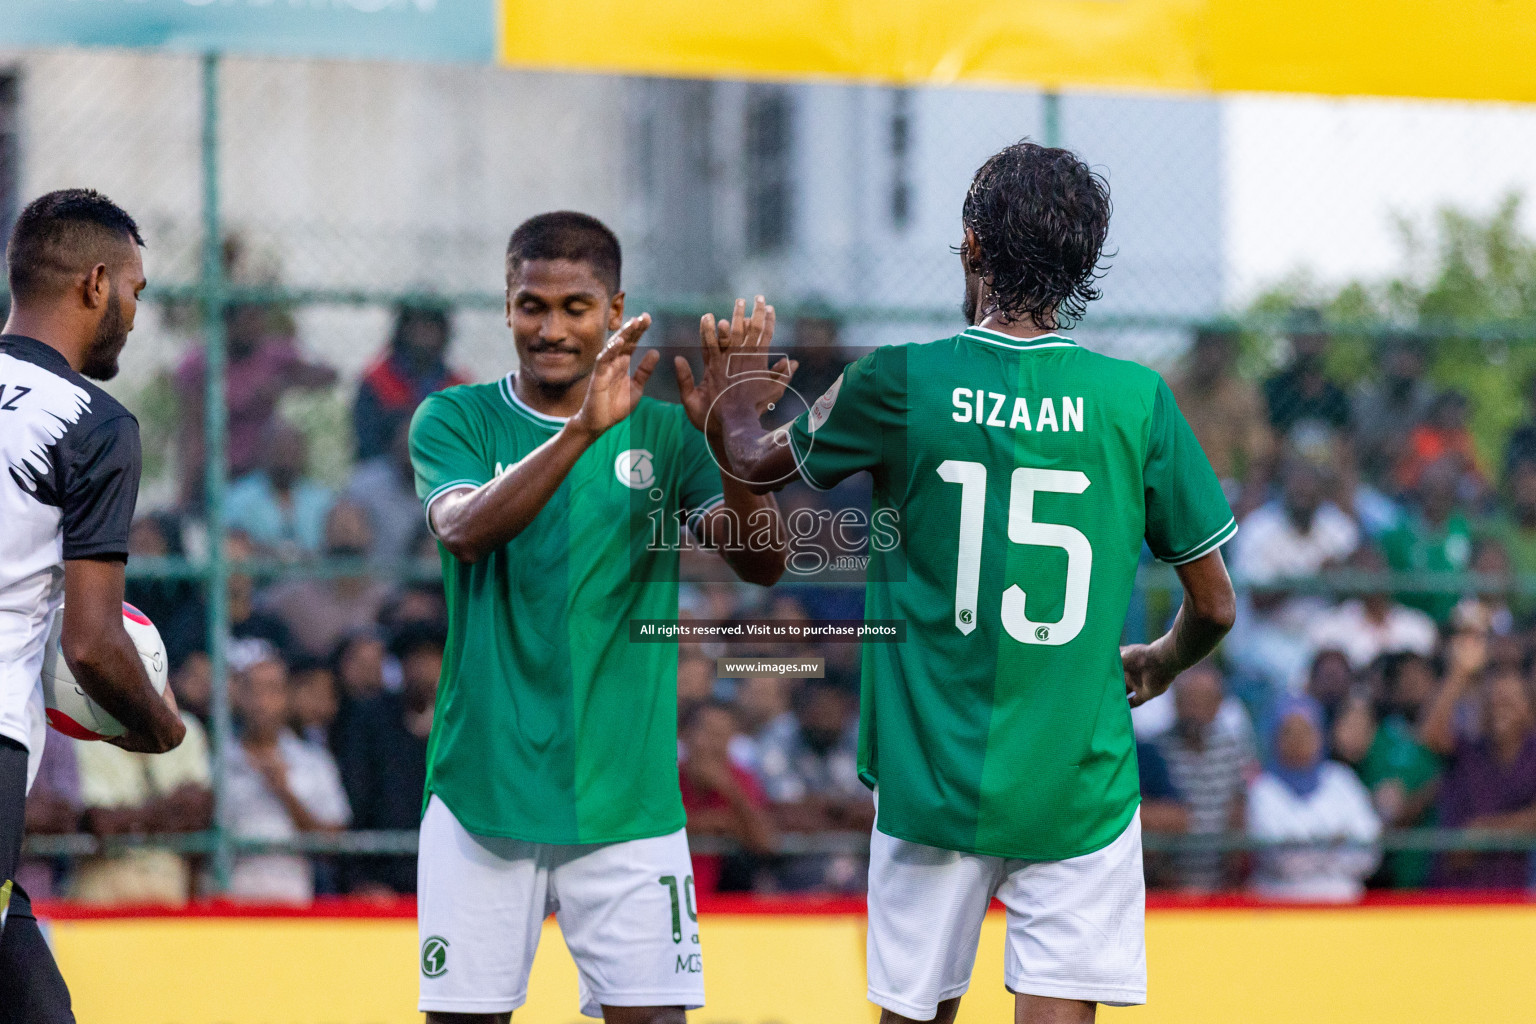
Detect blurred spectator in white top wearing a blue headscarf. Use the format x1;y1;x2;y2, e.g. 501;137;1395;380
1247;697;1381;903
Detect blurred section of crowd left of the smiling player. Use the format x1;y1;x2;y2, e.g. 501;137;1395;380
26;304;448;904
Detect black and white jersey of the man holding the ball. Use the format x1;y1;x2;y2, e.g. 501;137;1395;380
0;335;140;781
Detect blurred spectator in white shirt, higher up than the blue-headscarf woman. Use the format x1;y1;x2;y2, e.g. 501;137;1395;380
1227;457;1359;691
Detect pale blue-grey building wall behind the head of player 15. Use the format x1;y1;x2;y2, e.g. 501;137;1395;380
653;83;1224;361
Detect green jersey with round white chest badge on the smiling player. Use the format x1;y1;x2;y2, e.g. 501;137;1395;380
410;376;722;843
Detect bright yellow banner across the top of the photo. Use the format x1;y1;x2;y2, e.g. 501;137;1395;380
499;0;1536;101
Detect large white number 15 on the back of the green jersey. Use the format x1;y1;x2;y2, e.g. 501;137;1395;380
938;459;1094;646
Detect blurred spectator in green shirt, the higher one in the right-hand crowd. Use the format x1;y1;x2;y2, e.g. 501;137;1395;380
1381;457;1471;625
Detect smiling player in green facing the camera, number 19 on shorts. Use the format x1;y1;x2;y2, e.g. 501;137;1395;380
410;212;786;1024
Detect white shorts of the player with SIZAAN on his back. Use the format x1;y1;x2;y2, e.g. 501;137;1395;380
869;814;1147;1021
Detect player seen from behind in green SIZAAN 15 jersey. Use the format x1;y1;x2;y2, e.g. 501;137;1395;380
700;141;1236;1024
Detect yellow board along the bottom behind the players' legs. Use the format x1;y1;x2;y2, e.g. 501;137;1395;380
52;906;1536;1024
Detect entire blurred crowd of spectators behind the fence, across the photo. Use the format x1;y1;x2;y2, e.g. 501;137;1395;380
25;306;1536;904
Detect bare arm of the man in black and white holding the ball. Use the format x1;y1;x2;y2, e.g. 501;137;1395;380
61;559;187;754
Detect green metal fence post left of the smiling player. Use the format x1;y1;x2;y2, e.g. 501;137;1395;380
198;54;233;892
